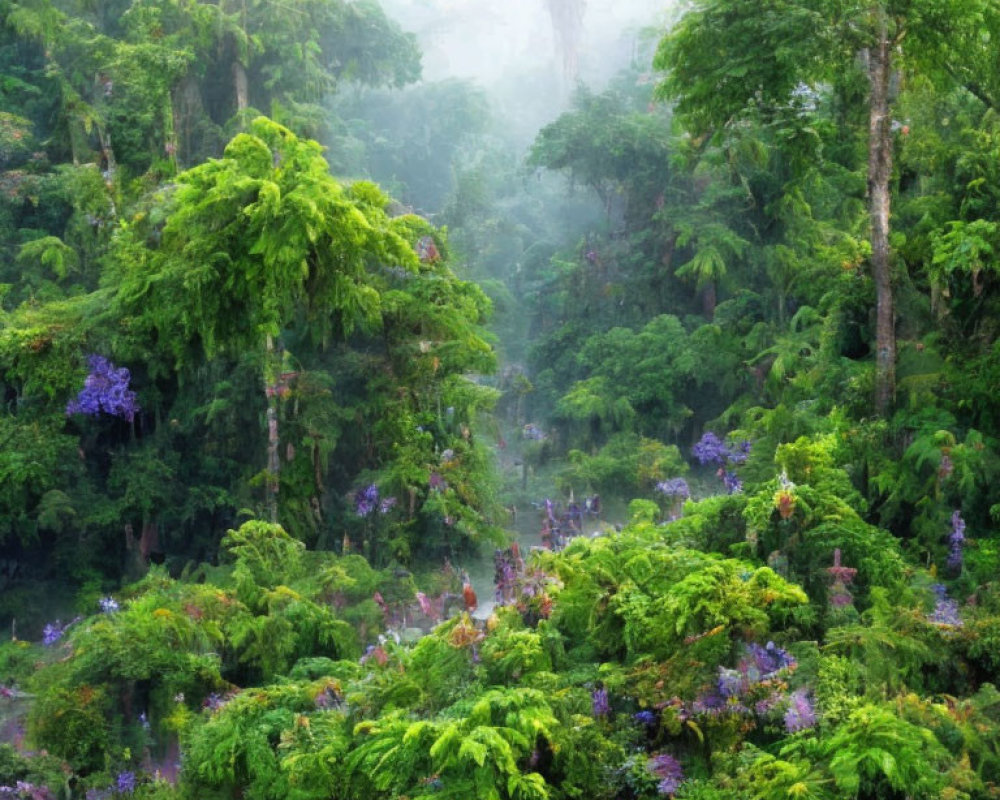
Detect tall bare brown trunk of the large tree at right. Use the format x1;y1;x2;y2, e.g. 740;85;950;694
868;12;896;417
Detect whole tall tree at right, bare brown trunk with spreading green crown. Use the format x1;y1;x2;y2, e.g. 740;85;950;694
655;0;984;415
